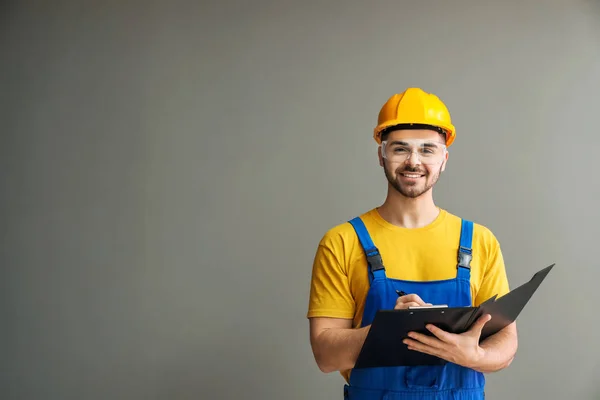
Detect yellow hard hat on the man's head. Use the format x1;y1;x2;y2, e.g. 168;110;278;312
373;88;456;146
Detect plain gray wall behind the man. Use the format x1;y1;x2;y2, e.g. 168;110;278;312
0;0;600;400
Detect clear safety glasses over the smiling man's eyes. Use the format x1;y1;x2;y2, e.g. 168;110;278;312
381;139;446;165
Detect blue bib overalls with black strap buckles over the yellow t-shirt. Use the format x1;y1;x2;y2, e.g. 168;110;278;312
344;217;485;400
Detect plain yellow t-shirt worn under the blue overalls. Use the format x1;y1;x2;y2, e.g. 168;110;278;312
307;208;509;379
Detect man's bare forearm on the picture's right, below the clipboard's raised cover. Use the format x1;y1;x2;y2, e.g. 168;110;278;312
473;323;518;373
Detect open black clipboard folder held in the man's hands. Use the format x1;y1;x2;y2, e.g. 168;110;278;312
354;264;555;369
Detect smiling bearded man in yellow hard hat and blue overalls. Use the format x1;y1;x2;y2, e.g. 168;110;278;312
307;88;517;400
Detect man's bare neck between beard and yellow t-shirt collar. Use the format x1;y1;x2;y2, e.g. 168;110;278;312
378;188;440;228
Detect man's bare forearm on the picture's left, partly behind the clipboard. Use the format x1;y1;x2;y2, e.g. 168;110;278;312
313;326;370;372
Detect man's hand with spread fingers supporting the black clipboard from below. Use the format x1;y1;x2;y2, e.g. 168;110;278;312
404;314;492;368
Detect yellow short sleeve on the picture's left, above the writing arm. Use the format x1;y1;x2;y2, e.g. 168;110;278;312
307;235;356;319
